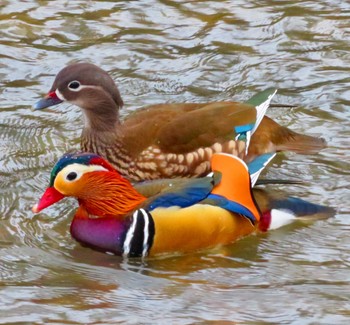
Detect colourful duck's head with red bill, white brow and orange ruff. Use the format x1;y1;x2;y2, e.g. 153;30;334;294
32;153;146;216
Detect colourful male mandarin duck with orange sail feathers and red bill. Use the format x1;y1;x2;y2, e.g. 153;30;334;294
33;153;334;257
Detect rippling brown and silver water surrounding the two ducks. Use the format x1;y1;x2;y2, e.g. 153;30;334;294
0;0;350;324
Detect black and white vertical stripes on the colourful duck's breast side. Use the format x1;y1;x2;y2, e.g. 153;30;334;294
123;209;155;257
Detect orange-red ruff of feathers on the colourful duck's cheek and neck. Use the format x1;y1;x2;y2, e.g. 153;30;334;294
76;173;146;219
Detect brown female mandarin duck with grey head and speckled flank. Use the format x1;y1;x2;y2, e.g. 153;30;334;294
34;63;325;181
